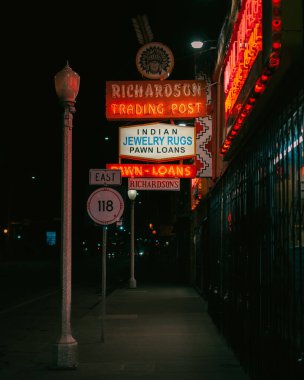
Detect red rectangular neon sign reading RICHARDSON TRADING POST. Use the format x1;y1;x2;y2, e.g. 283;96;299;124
106;80;207;120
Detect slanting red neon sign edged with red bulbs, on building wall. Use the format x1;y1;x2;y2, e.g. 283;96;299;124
221;0;282;155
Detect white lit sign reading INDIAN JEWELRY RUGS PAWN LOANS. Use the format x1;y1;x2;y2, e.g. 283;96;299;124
119;123;195;161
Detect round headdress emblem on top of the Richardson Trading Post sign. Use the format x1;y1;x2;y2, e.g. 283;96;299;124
136;42;174;79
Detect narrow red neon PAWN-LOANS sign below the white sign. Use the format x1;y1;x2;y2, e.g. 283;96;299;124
106;164;196;178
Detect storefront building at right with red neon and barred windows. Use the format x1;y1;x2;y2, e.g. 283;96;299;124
191;0;304;379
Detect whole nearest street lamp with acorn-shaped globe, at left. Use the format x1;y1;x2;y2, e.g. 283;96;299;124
54;63;80;369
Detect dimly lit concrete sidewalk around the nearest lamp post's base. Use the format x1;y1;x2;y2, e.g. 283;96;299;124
0;285;249;380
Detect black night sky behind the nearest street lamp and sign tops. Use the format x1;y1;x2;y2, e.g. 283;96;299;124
1;0;230;232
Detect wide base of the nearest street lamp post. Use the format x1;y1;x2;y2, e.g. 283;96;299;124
52;341;78;369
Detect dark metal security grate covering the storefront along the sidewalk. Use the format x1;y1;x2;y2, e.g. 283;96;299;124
204;90;304;378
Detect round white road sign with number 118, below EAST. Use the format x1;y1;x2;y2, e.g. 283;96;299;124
87;187;124;225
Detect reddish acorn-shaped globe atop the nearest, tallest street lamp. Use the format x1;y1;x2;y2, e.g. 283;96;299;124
55;63;80;102
